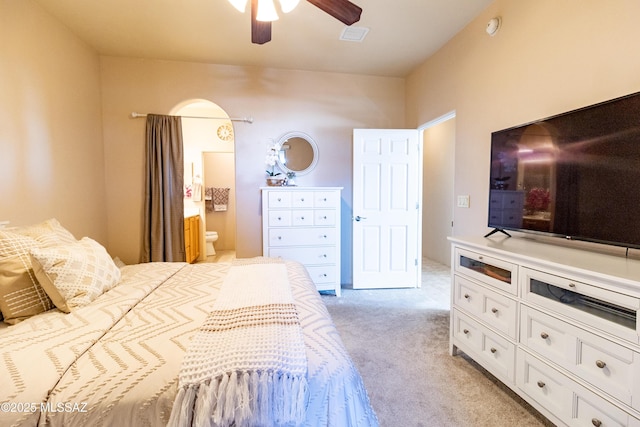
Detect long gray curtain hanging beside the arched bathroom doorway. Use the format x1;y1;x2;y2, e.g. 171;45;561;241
142;114;185;262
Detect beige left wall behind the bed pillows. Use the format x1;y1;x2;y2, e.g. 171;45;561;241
0;0;107;244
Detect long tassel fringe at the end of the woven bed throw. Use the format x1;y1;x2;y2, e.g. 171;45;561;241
168;371;308;427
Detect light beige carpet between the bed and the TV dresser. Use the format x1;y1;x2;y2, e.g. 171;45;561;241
323;259;553;427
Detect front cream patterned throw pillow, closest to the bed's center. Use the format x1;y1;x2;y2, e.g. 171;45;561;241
31;237;120;313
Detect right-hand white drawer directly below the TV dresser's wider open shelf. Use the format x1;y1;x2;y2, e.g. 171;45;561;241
520;305;640;408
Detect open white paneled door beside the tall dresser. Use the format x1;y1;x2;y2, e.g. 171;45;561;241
353;129;422;289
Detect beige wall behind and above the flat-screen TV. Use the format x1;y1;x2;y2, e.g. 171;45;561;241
406;0;640;241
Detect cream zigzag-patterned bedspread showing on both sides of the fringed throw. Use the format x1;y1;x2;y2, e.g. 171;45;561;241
0;262;378;427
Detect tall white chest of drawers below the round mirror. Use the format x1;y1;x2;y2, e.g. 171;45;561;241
261;187;342;296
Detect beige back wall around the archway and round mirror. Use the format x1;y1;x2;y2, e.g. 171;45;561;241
101;57;405;283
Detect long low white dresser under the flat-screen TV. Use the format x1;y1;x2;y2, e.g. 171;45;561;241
450;234;640;427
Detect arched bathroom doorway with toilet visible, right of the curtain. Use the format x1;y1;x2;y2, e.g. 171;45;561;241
171;99;236;262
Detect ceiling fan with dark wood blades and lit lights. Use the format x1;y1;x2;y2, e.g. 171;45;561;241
229;0;362;44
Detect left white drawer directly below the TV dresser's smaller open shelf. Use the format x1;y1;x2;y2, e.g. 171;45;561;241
454;275;518;340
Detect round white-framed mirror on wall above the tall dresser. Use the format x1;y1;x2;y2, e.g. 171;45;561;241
277;132;318;176
